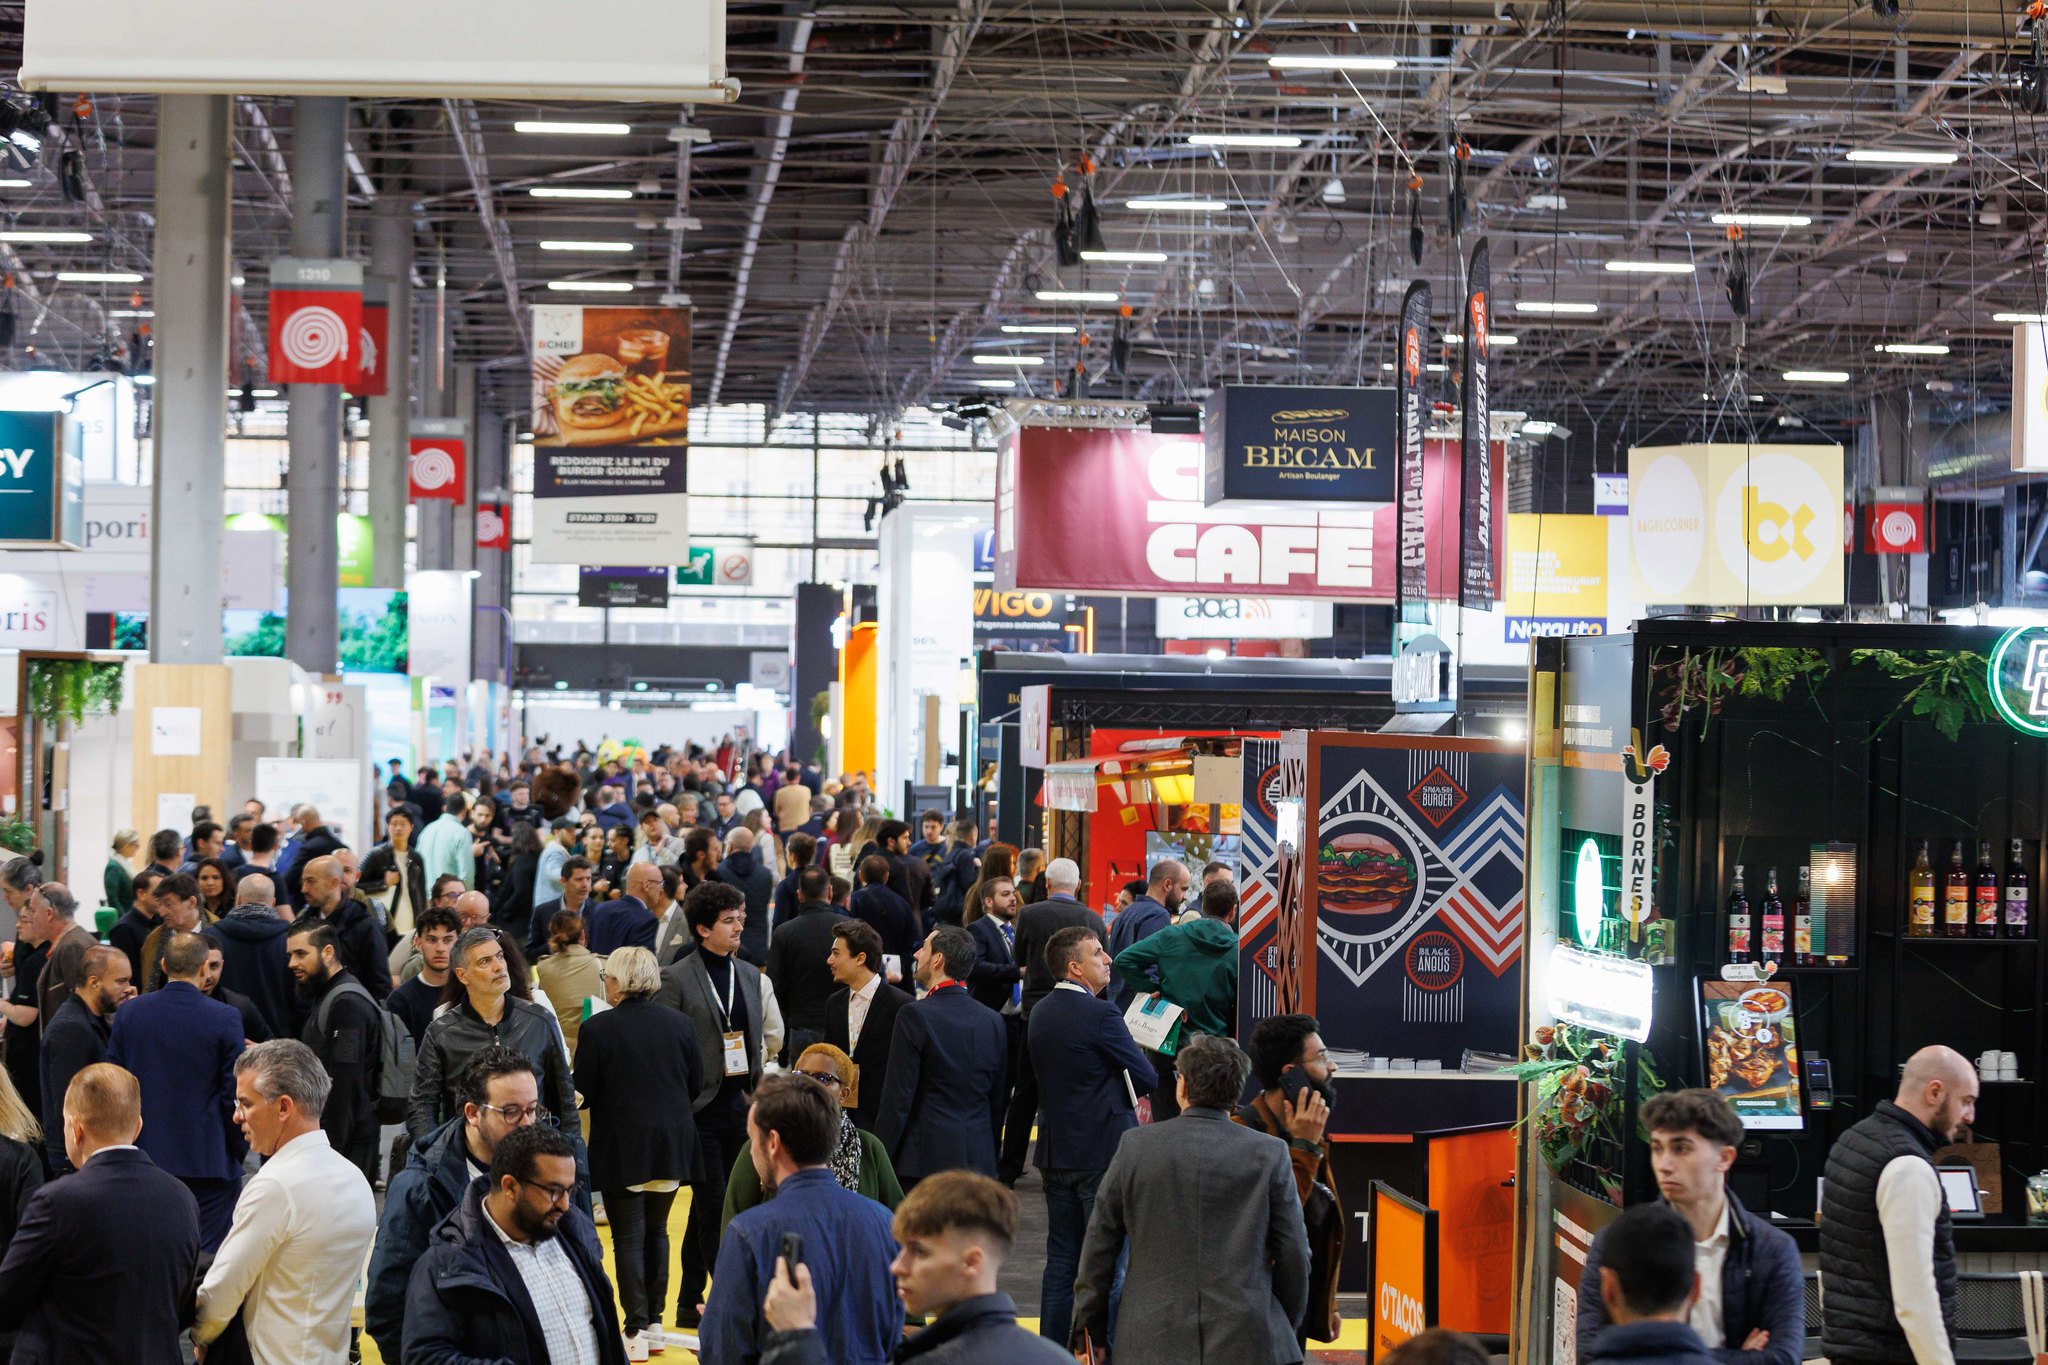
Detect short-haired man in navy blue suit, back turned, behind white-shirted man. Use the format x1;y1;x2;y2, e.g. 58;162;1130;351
106;933;248;1252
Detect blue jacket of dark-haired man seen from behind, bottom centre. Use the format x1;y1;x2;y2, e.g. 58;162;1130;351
700;1166;903;1365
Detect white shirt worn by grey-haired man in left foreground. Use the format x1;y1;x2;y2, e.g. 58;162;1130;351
193;1128;377;1365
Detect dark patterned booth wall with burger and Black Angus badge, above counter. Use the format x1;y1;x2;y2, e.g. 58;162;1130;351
1300;733;1526;1134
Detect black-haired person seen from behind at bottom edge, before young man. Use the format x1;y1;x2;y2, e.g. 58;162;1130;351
1581;1203;1714;1365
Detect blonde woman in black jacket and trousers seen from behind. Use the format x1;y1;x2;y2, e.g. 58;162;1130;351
575;948;705;1361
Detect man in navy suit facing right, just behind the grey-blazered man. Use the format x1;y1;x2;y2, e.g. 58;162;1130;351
1030;925;1159;1347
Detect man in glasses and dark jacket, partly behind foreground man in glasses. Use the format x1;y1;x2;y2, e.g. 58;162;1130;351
362;1046;549;1361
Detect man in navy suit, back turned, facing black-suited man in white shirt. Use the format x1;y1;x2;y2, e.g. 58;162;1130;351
874;925;1006;1189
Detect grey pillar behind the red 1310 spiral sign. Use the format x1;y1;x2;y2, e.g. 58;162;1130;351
285;94;348;673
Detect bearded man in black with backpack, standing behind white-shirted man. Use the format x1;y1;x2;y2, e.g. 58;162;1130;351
285;917;383;1185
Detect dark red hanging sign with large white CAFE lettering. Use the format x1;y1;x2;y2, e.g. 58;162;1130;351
995;426;1505;602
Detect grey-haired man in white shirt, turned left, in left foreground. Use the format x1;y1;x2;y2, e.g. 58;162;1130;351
193;1038;377;1365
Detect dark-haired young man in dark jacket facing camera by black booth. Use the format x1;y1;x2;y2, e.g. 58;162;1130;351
1579;1091;1806;1365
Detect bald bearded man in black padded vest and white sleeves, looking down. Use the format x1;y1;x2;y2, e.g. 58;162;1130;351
1819;1046;1976;1365
